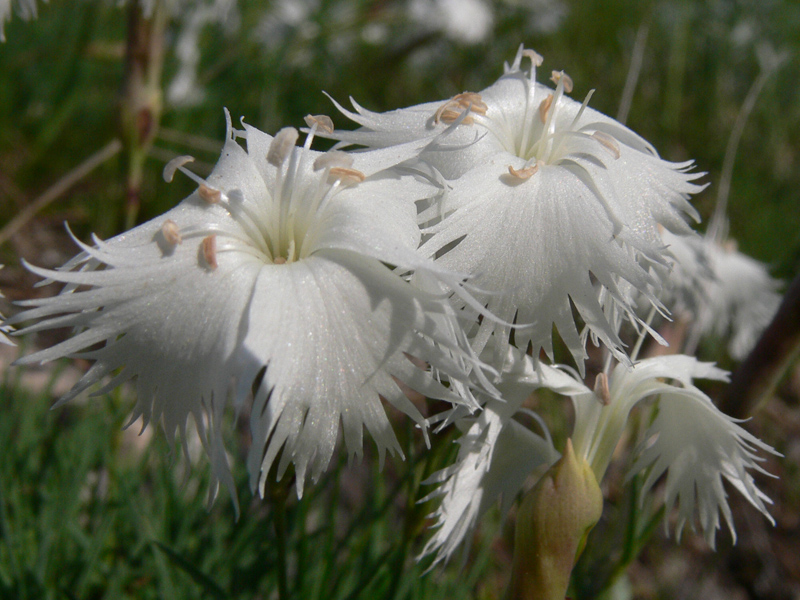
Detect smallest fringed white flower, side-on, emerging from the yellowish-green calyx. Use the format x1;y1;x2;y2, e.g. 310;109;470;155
424;351;777;562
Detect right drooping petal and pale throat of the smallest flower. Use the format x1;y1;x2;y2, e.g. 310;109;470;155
572;355;778;548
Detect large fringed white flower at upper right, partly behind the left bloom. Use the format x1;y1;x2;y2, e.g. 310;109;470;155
334;48;702;369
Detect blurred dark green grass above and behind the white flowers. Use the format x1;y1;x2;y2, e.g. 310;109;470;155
0;0;800;277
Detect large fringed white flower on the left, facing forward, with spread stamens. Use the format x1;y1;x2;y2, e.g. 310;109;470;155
14;111;482;502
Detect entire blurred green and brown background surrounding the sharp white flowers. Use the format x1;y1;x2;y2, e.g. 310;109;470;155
0;0;800;600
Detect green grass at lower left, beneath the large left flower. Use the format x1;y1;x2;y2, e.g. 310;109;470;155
0;360;500;600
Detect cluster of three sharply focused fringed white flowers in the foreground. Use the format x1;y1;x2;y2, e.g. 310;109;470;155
4;47;774;560
